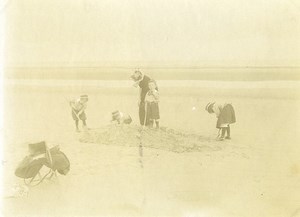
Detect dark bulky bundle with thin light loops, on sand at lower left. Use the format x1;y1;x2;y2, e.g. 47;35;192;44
15;141;70;186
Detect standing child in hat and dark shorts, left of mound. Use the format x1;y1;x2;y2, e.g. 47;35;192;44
70;95;89;132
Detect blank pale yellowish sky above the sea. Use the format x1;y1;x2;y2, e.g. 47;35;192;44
2;0;300;66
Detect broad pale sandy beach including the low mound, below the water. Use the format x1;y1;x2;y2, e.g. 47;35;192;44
2;80;300;217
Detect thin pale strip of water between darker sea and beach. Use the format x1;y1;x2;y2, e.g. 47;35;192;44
3;79;300;89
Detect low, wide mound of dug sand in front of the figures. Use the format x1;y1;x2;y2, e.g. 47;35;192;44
79;125;221;153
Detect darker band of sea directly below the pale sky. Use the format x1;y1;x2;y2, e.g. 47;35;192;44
4;67;300;81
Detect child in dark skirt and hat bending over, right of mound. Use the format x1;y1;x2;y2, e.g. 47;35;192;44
205;102;236;141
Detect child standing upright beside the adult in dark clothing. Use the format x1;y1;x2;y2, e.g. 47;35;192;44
145;80;160;128
